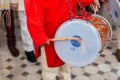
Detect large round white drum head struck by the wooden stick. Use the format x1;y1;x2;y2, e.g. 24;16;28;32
54;19;101;67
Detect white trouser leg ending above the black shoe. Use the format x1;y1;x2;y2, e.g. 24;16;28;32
18;11;34;52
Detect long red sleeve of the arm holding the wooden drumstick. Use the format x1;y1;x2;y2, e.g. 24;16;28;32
24;0;48;46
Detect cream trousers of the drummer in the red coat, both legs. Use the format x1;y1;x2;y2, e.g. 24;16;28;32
40;47;71;80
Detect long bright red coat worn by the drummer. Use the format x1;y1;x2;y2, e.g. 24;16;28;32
24;0;93;67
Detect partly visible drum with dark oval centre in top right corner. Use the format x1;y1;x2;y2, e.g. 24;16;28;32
109;0;120;27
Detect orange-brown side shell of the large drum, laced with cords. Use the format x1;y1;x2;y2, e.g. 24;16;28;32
90;15;112;49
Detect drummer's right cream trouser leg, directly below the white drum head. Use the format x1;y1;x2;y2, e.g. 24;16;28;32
59;64;71;80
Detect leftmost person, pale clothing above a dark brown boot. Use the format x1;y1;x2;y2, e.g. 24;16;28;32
0;0;19;57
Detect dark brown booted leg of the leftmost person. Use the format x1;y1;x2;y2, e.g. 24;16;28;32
2;10;19;57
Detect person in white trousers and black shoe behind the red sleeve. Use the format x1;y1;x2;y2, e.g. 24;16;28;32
11;0;36;62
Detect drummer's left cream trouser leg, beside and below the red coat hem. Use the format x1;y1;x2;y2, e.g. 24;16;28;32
40;47;59;80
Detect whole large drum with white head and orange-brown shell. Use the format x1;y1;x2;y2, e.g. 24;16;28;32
54;15;112;67
